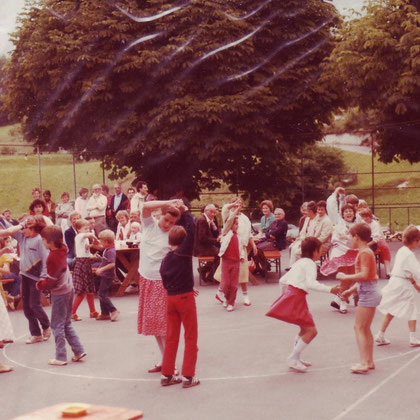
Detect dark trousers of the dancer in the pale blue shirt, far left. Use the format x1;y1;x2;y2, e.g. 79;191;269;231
22;276;50;337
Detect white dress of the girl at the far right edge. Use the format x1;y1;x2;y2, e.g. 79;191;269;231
378;246;420;320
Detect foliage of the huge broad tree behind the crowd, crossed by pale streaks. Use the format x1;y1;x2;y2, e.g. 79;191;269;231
6;0;338;198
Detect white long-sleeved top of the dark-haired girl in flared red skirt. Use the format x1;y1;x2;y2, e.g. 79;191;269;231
280;258;331;293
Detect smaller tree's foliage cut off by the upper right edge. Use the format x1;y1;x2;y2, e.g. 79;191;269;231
323;0;420;162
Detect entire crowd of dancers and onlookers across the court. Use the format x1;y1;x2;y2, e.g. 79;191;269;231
0;181;420;388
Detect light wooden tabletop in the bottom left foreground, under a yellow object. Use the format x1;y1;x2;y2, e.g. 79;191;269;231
12;403;143;420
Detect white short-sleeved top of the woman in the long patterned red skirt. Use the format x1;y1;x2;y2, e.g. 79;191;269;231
139;215;171;280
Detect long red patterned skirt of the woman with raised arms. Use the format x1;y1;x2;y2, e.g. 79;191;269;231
137;276;167;337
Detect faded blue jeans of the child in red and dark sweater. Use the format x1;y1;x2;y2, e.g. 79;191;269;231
51;291;84;361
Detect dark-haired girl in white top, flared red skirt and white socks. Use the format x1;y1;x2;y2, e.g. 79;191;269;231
266;237;340;372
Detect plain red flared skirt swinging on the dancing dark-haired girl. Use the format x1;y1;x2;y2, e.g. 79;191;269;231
265;285;315;327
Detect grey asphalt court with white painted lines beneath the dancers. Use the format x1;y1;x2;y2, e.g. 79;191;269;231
0;244;420;420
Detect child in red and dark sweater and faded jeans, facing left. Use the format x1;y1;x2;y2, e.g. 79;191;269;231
36;226;86;366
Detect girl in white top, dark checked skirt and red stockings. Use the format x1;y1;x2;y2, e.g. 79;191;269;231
72;219;99;321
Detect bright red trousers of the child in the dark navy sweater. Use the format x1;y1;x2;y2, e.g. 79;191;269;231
162;292;198;376
